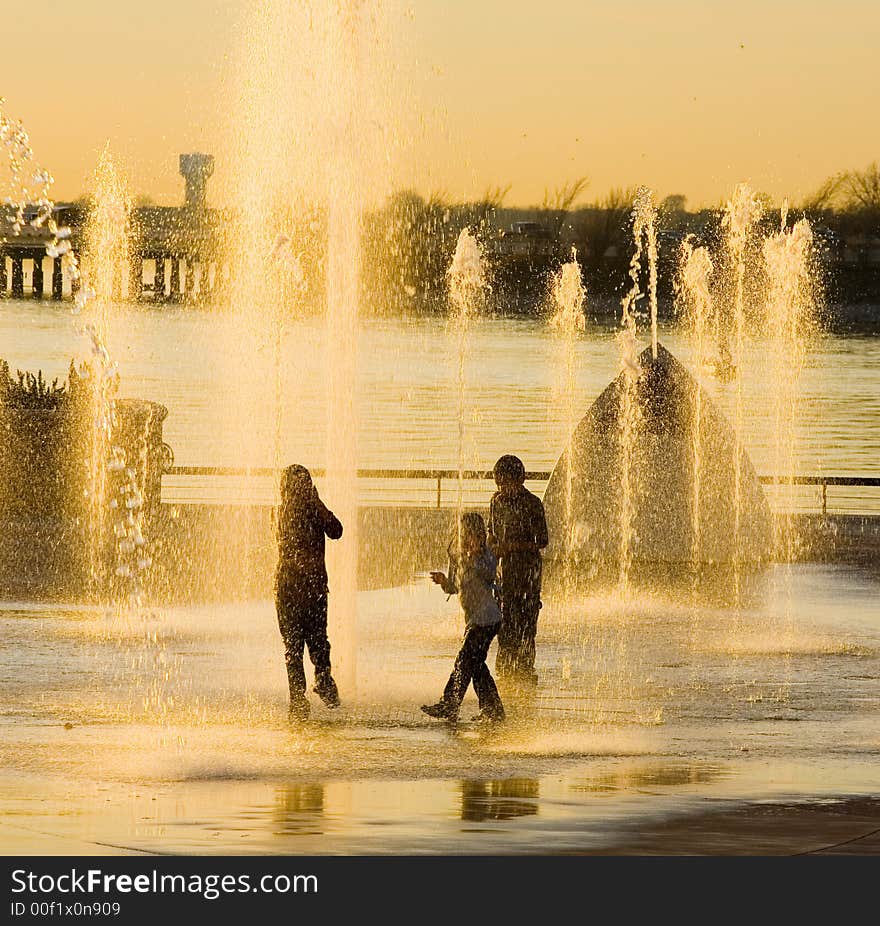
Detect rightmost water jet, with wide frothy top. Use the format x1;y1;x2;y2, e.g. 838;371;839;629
763;209;816;562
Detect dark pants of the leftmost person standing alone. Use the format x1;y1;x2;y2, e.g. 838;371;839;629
275;585;332;703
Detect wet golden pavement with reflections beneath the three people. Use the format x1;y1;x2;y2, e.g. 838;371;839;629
0;565;880;854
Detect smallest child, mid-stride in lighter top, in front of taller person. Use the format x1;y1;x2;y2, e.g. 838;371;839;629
422;513;504;721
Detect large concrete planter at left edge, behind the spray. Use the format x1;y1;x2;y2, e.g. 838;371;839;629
0;399;169;598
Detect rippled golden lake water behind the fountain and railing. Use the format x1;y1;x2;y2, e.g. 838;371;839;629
0;301;880;510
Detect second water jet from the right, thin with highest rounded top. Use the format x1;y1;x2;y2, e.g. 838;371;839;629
722;183;761;576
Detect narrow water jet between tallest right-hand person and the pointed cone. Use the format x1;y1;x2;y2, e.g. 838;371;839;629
549;248;587;595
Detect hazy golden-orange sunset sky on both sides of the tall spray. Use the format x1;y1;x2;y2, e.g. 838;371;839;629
0;0;880;206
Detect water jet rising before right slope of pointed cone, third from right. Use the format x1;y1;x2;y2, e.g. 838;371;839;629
678;236;715;565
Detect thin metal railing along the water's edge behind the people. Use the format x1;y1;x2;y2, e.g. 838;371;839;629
164;466;880;515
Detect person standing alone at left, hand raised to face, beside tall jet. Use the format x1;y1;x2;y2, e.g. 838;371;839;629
275;465;342;720
